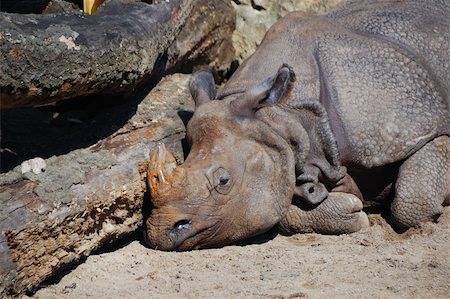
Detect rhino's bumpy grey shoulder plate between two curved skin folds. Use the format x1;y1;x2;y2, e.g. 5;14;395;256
315;25;450;167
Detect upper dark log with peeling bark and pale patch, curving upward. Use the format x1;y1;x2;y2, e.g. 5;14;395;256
0;0;192;108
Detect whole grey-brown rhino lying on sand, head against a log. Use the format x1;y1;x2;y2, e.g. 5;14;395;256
145;0;450;250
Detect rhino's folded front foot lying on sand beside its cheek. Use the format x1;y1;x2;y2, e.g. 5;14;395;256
279;192;369;235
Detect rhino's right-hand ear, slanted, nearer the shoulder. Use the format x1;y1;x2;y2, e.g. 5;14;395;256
232;64;295;114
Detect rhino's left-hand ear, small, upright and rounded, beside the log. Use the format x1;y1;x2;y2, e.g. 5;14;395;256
189;70;216;107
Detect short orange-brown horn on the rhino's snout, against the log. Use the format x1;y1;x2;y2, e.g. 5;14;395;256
147;143;177;199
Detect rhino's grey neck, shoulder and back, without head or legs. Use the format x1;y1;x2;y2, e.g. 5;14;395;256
221;1;450;167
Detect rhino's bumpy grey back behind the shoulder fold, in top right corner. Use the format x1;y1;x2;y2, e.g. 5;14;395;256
327;0;450;84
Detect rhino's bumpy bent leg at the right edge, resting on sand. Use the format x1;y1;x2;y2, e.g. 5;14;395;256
391;136;450;230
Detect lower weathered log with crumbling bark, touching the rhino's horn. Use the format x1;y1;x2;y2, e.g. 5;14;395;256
0;74;193;297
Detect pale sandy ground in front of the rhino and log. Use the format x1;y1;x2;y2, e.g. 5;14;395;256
23;207;450;299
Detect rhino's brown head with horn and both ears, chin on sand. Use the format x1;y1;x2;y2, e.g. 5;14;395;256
146;66;340;250
